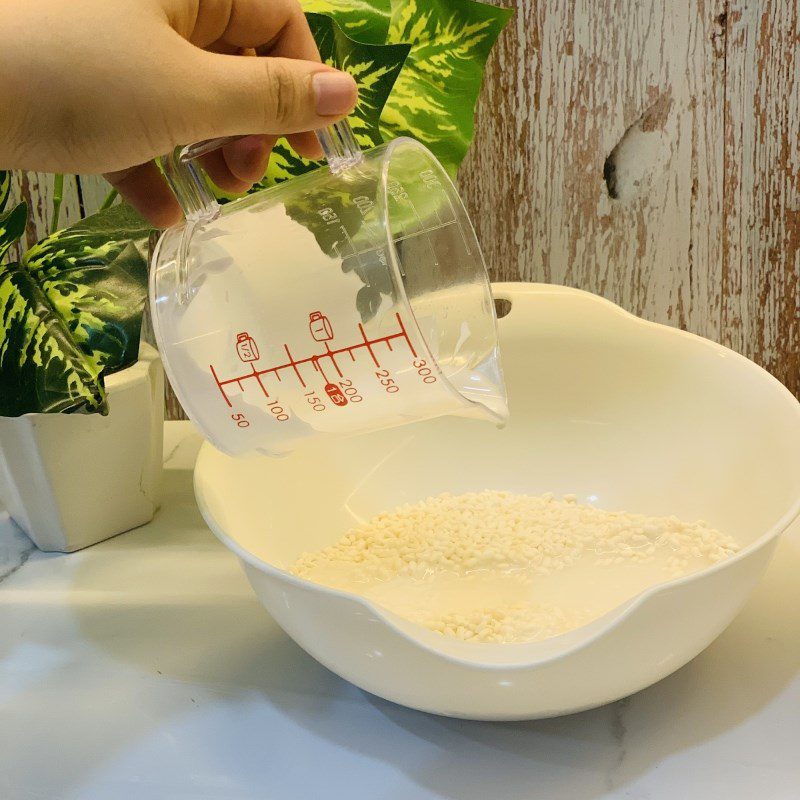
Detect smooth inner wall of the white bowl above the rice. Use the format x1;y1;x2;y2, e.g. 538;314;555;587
198;284;800;620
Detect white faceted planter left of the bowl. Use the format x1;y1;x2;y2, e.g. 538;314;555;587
0;344;164;552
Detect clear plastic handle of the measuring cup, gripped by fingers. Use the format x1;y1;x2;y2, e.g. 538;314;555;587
160;119;362;220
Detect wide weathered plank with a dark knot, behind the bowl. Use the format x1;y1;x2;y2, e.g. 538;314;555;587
461;0;724;335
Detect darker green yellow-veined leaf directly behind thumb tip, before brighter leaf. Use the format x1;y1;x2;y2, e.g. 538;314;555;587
254;14;410;191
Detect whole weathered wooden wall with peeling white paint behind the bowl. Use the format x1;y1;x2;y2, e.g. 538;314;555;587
7;0;800;415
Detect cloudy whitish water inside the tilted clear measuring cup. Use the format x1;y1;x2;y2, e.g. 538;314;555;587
155;196;502;454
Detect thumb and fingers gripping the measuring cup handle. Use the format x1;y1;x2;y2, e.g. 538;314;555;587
107;0;350;227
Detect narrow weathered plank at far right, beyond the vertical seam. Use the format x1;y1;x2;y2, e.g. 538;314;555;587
722;0;800;395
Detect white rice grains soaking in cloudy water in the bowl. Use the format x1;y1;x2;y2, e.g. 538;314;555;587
291;491;738;642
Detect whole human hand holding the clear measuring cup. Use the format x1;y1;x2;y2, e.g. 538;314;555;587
0;0;357;226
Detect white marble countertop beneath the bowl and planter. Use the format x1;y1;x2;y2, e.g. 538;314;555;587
0;423;800;800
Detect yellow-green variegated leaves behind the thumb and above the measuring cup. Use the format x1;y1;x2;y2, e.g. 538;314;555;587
256;0;511;190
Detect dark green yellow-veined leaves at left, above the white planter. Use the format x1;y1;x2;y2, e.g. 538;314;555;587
0;194;149;416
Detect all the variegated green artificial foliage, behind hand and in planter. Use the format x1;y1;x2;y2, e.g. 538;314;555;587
0;0;510;416
